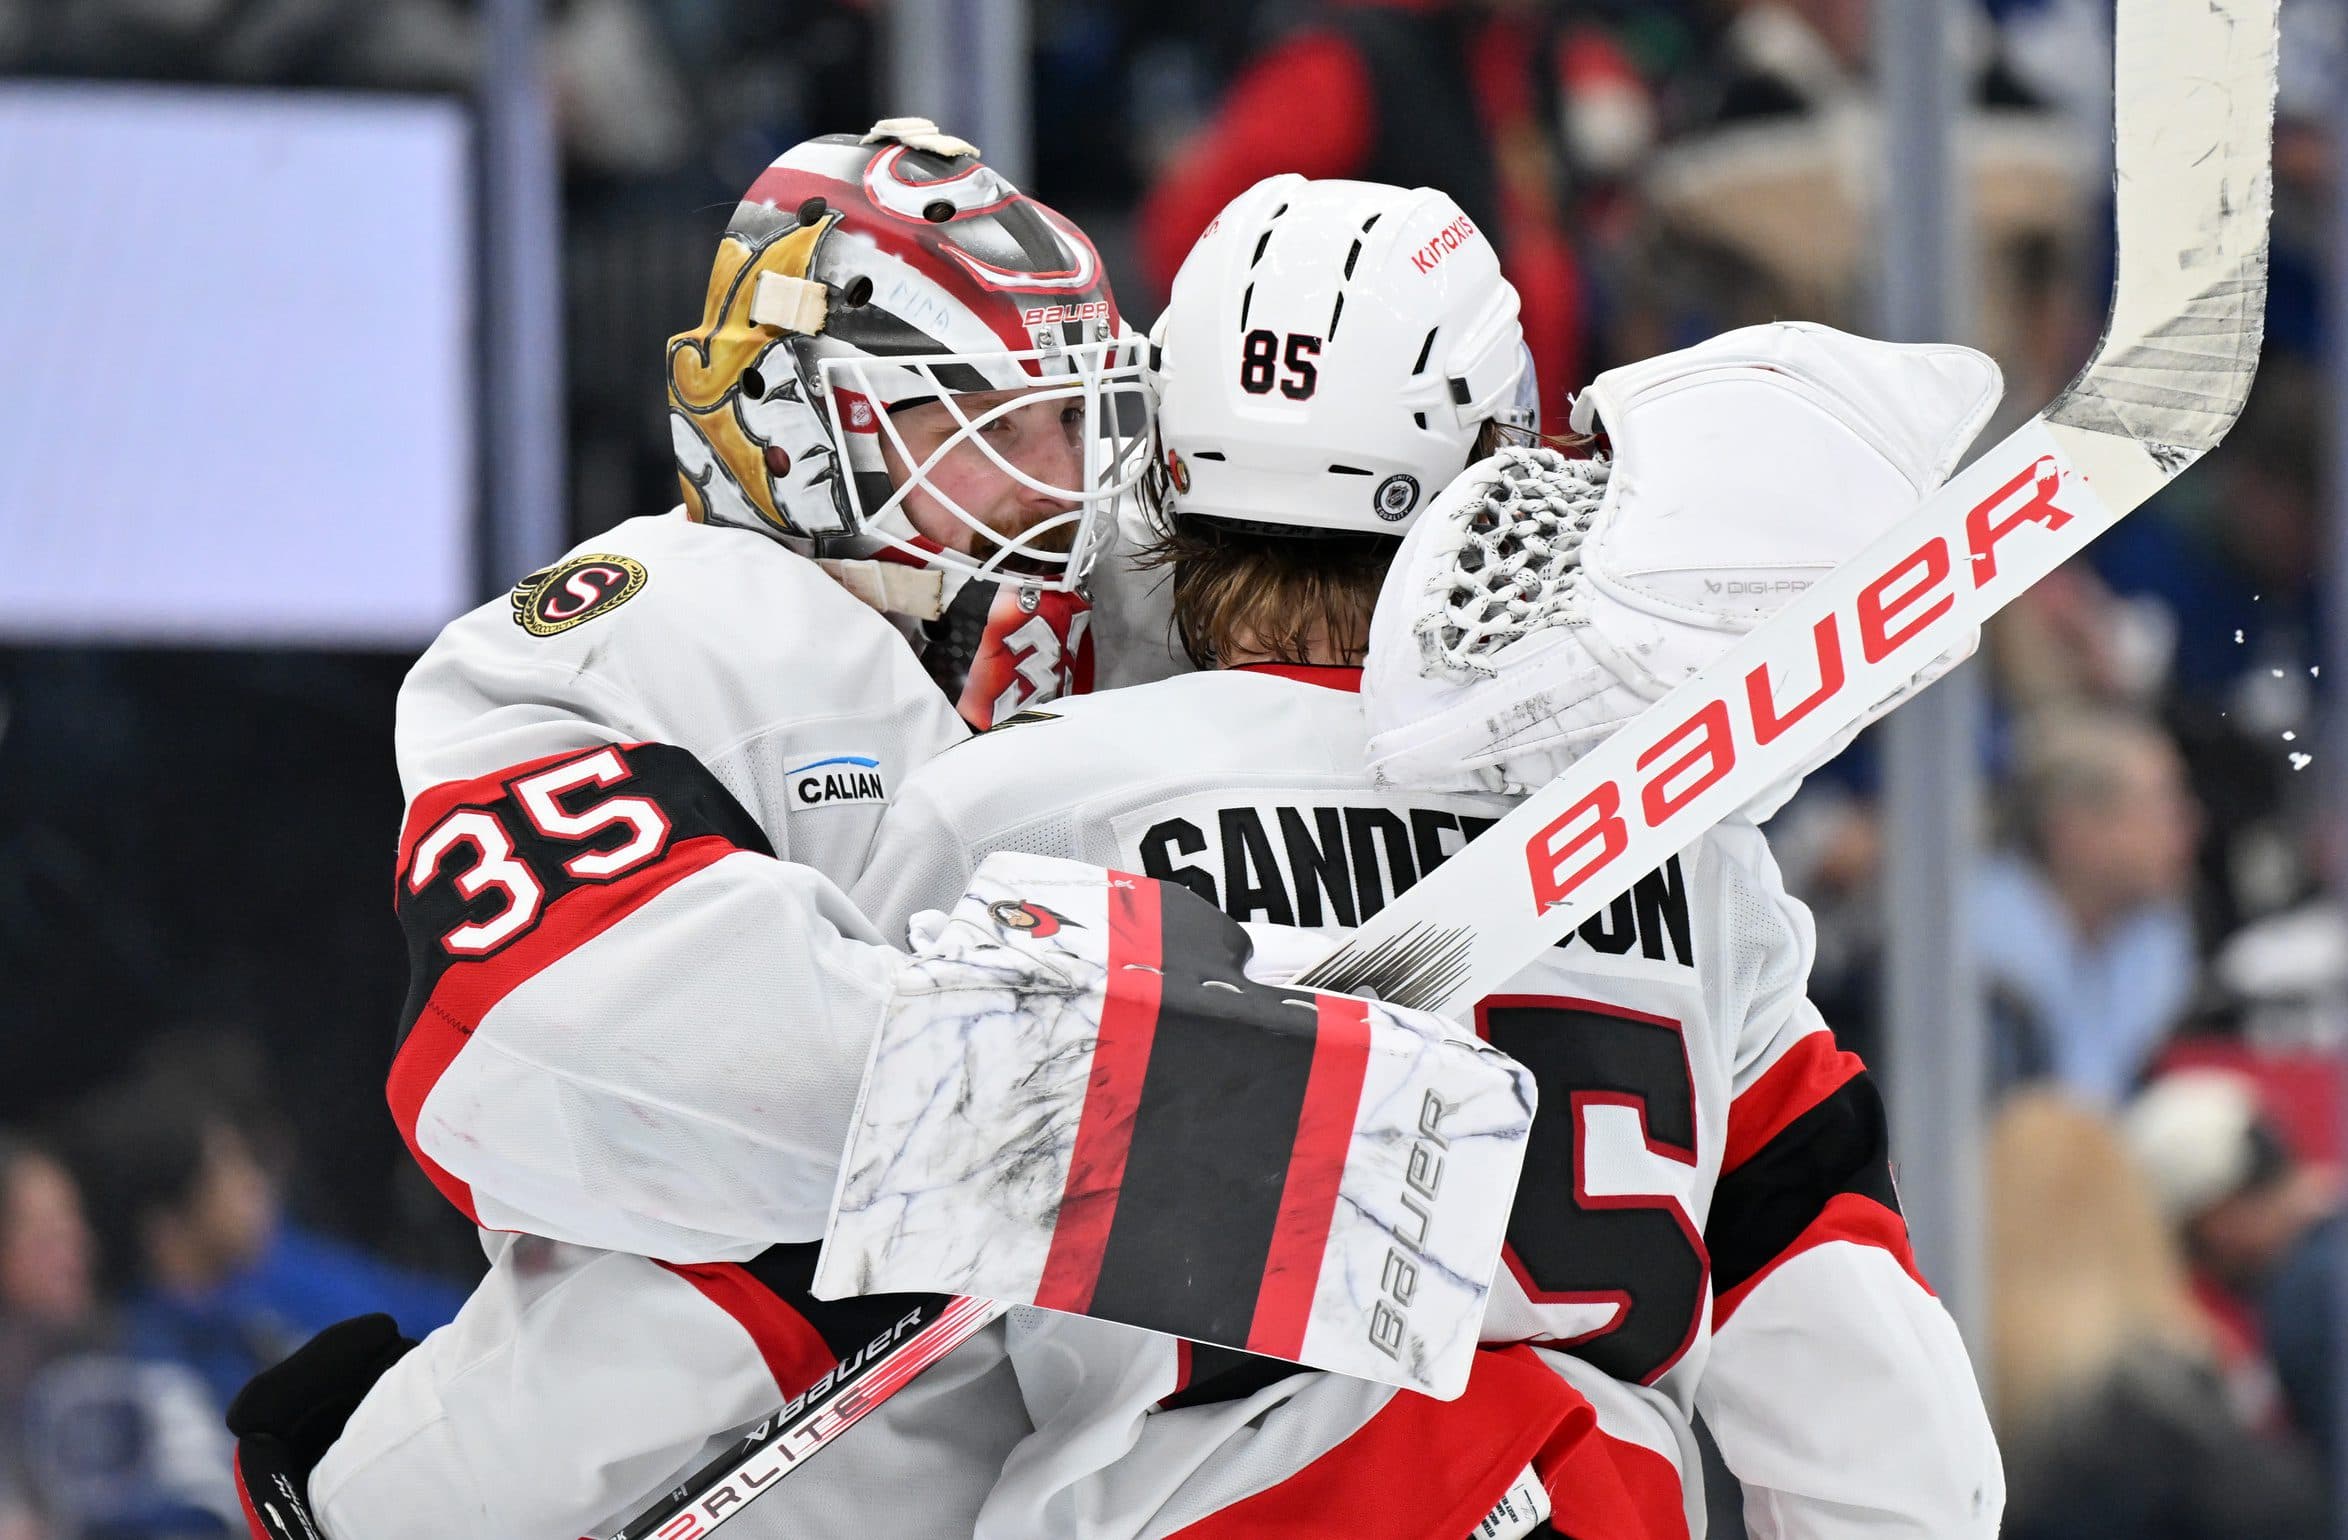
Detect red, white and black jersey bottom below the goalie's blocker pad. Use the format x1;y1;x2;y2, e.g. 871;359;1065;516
977;1310;1693;1540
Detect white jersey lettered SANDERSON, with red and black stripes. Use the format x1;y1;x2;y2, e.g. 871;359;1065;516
852;667;2003;1540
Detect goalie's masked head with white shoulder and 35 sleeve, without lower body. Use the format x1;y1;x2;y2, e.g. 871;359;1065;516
390;120;1164;1261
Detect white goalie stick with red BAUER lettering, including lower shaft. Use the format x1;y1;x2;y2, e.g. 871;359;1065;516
610;0;2278;1540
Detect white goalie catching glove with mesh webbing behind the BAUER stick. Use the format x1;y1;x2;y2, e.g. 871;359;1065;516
1362;322;2003;807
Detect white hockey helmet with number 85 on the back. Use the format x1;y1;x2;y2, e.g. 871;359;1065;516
1148;174;1538;535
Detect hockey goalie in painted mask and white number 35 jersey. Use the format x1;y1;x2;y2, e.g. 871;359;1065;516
235;120;1512;1540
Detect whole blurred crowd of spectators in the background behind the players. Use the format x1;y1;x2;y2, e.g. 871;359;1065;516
0;0;2348;1540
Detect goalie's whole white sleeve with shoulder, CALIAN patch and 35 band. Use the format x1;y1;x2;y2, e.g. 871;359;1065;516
387;526;960;1263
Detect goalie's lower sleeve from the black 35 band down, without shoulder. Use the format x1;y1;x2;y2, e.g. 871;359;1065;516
387;744;899;1261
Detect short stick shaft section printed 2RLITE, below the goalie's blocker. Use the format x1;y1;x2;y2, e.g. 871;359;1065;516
608;1298;1010;1540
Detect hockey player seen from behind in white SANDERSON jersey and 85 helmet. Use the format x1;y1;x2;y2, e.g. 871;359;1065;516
855;176;2003;1540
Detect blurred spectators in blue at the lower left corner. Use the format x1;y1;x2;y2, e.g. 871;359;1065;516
0;1028;465;1540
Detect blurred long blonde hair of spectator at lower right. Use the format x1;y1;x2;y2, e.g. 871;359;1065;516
1989;1092;2209;1432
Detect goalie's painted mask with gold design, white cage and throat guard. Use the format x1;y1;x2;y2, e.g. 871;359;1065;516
669;117;1148;728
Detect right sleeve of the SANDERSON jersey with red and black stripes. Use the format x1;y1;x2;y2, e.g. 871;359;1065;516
1695;835;2005;1540
